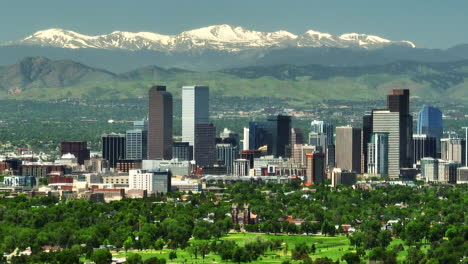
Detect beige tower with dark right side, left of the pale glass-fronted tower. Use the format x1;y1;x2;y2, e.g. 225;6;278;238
335;126;362;173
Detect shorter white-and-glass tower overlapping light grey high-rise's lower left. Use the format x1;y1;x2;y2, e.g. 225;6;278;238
367;132;388;177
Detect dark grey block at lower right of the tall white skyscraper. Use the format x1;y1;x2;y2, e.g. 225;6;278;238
193;124;216;167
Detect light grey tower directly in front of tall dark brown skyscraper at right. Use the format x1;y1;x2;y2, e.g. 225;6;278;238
372;110;401;178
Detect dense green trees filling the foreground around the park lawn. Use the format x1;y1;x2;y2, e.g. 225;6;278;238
0;182;468;263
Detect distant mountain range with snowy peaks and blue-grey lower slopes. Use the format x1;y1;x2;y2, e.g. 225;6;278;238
0;25;468;73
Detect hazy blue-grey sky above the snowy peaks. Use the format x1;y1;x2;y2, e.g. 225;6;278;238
0;0;468;48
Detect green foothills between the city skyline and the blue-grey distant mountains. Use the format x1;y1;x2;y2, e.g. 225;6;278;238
0;57;468;105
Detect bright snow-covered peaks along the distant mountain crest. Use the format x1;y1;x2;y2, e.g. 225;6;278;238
6;25;416;52
